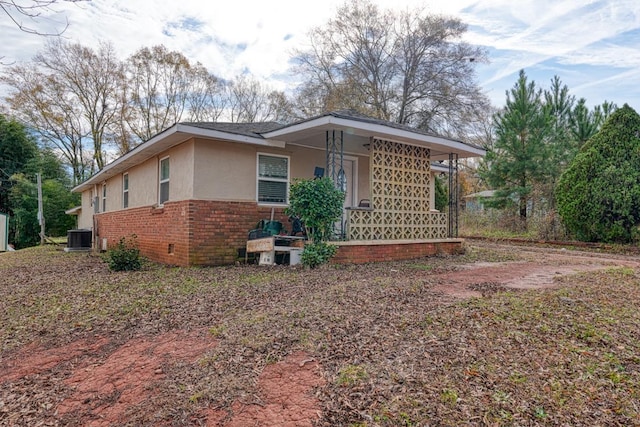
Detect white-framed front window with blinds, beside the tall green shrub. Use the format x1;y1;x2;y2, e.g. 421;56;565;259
258;154;289;204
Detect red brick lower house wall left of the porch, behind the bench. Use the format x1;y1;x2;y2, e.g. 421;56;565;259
95;200;291;266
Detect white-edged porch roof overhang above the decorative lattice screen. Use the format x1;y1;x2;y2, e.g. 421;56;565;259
262;112;486;161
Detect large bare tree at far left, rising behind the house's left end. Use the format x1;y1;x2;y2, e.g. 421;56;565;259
1;39;122;183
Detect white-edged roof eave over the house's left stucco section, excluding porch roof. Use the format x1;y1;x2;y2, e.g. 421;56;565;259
71;123;285;193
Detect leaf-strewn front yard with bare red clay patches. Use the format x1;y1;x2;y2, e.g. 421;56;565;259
0;242;640;427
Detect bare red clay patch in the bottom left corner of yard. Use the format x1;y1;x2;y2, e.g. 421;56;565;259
0;331;216;427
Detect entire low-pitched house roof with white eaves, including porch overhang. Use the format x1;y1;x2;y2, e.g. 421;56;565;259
71;111;486;193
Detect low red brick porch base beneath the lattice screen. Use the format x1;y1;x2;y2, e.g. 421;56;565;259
331;241;462;264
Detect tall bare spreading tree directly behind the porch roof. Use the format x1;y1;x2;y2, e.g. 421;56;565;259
296;0;488;133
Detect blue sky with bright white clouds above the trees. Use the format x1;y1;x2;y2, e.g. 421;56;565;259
0;0;640;112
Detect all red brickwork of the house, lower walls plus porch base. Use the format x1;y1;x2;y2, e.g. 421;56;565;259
94;200;463;266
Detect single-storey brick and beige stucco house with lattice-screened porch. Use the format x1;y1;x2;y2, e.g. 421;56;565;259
73;111;484;265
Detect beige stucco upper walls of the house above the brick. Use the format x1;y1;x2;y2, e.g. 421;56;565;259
78;139;370;224
